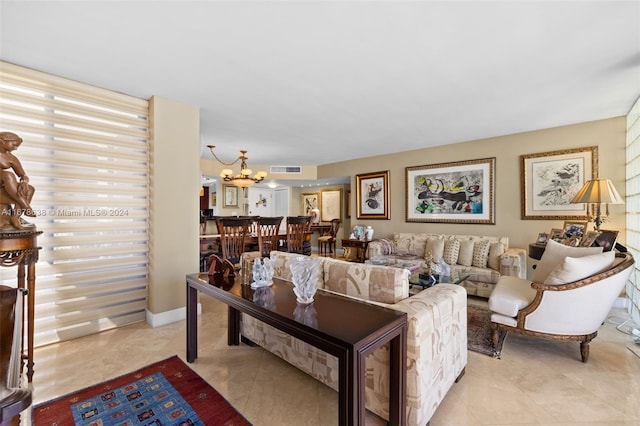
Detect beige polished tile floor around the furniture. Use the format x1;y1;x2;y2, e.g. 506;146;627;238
23;296;640;426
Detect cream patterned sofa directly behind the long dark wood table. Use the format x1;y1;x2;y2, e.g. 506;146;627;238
241;251;467;425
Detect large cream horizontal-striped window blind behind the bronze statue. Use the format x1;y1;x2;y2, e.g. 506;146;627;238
0;62;149;346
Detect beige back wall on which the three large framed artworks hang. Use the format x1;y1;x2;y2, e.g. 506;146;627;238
318;117;626;249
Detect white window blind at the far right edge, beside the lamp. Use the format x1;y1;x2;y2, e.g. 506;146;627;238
625;99;640;325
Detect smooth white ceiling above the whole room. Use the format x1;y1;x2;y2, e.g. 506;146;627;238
0;1;640;170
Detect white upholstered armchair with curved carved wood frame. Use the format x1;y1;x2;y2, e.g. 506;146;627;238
489;242;634;362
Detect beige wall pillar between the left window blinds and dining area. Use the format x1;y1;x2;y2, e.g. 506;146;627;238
148;96;201;314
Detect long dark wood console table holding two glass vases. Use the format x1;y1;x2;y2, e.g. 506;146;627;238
187;273;407;425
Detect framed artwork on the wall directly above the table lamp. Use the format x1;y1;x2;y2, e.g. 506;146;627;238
520;146;598;220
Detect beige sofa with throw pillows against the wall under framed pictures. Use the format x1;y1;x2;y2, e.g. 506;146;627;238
367;233;527;298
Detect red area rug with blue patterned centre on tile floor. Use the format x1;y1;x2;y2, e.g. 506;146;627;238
33;356;250;426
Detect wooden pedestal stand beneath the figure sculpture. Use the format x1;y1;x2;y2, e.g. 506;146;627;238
0;228;42;382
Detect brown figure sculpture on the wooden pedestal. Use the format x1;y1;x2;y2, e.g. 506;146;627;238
0;132;36;230
